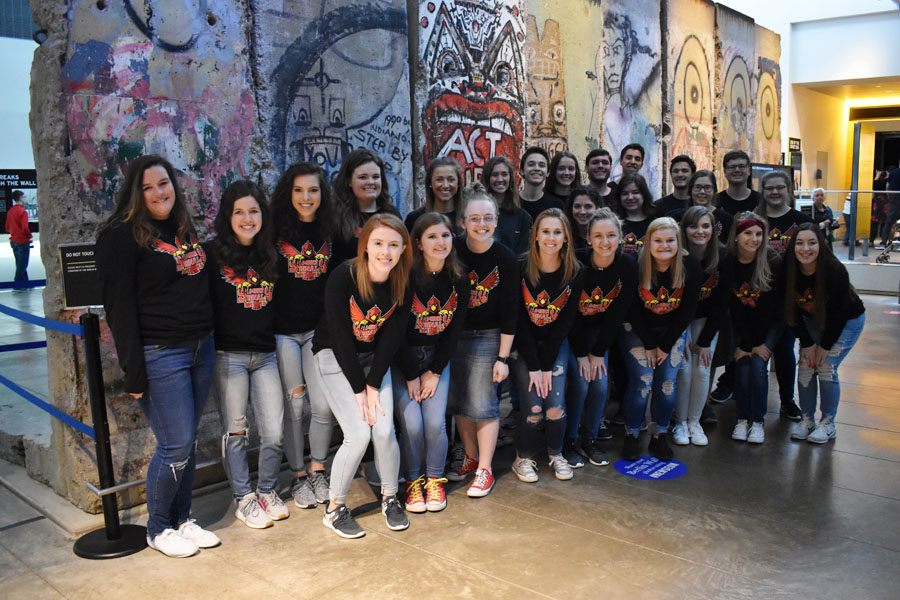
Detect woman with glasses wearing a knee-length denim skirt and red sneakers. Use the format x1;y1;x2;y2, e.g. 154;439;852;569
447;184;519;498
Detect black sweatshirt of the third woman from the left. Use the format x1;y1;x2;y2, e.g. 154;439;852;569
274;221;338;335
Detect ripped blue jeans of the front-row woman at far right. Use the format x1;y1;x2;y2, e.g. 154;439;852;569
797;314;866;420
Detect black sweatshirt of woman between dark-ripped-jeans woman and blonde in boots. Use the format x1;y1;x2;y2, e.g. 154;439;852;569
569;248;638;357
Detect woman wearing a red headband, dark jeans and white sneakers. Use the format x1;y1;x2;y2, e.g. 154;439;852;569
728;212;779;444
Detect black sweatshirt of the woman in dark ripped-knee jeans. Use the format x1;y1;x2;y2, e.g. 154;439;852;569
515;259;581;371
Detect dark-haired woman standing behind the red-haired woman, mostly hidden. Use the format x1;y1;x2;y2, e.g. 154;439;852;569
333;148;400;263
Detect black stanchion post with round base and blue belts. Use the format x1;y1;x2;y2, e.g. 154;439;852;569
74;313;147;559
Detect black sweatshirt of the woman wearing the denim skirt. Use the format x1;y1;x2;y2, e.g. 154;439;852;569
454;237;521;335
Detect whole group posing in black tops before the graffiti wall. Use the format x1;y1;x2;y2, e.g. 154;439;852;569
97;144;864;556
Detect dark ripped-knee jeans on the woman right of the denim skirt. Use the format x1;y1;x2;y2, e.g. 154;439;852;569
509;341;569;458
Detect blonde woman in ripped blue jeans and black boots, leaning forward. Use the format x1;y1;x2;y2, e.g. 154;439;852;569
622;217;700;460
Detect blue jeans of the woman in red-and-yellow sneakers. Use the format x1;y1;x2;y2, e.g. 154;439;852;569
391;346;450;481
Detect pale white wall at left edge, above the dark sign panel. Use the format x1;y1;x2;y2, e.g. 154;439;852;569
0;37;37;169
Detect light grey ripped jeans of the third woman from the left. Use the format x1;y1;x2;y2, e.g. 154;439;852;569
275;331;334;472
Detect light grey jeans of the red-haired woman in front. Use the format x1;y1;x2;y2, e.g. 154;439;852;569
315;348;400;504
